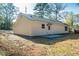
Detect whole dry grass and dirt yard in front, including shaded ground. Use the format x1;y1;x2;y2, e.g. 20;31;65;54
0;33;79;56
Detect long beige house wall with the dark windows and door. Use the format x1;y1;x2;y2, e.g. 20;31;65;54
30;21;68;36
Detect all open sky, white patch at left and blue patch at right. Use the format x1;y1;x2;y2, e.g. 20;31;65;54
14;3;79;14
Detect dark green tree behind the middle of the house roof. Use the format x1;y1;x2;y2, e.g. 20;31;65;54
34;3;49;18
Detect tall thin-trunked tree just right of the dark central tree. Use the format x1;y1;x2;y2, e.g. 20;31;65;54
52;3;66;20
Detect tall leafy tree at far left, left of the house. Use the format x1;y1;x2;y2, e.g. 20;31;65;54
0;3;18;30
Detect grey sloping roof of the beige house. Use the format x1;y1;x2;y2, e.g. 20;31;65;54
19;13;66;25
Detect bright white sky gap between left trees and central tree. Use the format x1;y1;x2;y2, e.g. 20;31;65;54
14;3;35;14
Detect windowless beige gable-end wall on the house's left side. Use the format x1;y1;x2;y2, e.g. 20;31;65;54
13;17;32;36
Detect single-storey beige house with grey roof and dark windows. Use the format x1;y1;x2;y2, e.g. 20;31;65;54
13;13;69;36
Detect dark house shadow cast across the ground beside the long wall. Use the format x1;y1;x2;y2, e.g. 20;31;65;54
15;34;79;45
